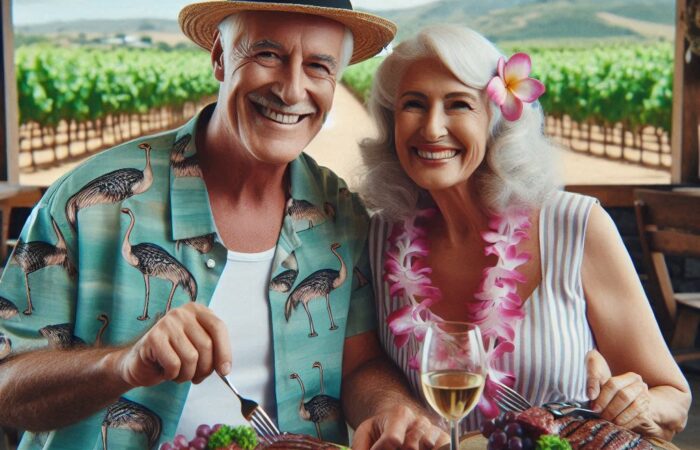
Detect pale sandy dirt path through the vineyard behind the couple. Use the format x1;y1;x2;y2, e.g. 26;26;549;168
20;85;671;186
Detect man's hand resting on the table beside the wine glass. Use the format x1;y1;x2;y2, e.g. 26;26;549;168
352;405;450;450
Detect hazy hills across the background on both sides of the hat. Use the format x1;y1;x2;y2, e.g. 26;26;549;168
16;0;675;45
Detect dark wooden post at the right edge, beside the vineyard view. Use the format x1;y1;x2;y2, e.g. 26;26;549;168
671;0;700;183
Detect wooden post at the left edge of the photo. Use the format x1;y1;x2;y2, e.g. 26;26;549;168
0;0;19;183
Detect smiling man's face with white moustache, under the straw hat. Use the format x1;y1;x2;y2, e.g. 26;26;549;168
212;12;344;164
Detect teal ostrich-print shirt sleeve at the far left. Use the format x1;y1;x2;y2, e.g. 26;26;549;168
0;194;78;358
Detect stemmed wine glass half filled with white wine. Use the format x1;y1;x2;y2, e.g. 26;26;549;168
420;322;486;450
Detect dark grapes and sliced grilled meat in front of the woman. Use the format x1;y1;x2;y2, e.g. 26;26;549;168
481;407;654;450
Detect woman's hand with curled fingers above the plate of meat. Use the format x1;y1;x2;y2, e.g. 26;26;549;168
586;350;663;436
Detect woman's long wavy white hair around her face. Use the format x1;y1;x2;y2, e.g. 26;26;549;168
359;25;558;220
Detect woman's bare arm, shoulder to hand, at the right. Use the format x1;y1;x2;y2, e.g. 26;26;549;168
581;205;691;439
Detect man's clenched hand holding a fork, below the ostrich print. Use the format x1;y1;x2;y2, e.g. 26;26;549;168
114;303;231;387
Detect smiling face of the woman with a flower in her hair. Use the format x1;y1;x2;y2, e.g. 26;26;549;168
394;58;490;191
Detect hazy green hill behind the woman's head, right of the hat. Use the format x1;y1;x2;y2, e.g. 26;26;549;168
370;0;675;42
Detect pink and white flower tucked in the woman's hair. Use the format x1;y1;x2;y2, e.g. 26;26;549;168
486;53;545;121
